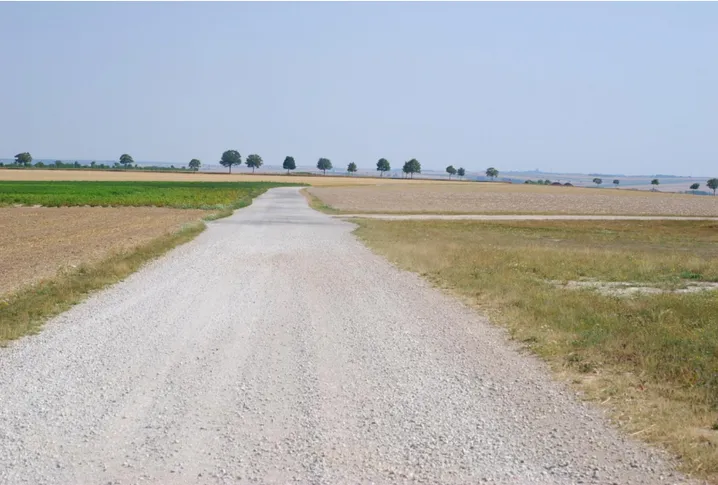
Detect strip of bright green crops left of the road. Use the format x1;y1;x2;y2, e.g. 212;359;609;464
0;181;294;209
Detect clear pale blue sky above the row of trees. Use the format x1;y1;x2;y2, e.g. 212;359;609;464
0;3;718;176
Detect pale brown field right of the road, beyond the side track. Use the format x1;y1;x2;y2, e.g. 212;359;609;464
308;183;718;217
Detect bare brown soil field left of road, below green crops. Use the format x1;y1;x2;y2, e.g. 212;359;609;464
0;207;207;295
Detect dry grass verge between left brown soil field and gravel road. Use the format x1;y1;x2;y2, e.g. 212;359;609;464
0;221;206;343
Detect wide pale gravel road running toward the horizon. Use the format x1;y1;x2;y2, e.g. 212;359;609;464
0;188;696;484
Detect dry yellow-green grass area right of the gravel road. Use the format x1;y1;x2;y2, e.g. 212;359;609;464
356;219;718;482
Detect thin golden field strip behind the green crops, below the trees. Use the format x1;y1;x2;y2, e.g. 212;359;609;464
0;169;456;186
